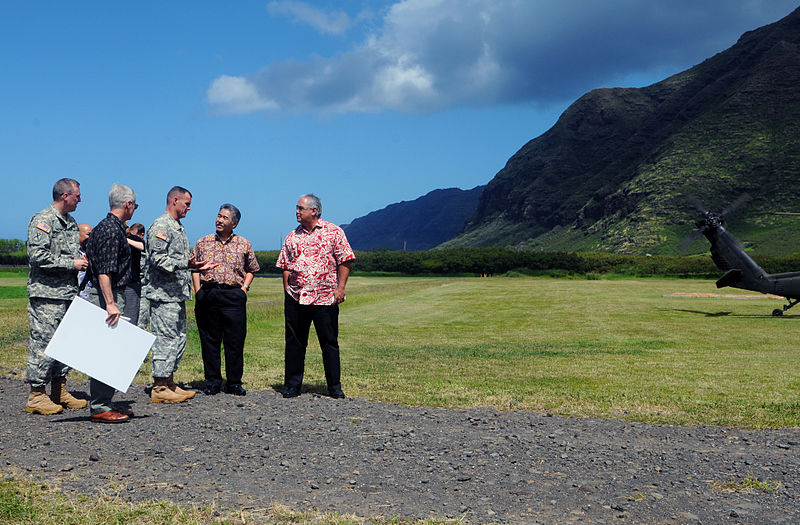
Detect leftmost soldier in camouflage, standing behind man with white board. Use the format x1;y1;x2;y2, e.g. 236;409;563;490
25;179;88;414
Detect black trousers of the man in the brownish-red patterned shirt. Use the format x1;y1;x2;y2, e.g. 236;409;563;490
194;285;247;385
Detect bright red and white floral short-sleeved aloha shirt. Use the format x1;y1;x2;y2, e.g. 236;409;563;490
275;219;356;305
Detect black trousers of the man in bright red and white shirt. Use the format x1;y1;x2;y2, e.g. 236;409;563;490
283;292;341;390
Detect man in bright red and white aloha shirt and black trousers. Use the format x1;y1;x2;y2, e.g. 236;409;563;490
275;194;355;399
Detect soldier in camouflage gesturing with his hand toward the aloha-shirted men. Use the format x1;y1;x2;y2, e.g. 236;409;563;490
142;186;214;403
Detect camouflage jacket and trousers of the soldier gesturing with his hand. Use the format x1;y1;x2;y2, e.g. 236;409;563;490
142;213;192;378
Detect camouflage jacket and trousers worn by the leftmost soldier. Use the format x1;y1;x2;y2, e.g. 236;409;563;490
25;204;80;388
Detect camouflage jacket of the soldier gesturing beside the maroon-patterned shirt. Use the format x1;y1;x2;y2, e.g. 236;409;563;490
142;213;192;303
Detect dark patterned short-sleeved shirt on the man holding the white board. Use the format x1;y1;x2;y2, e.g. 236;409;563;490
86;213;133;292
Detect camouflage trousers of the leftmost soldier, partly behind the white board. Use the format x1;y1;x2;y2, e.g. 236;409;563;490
25;297;72;388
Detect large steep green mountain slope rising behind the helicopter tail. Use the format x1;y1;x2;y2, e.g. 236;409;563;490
443;9;800;254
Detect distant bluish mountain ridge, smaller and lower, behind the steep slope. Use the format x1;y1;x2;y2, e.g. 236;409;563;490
342;186;484;251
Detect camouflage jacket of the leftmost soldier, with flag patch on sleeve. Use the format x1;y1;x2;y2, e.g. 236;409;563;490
28;204;81;300
